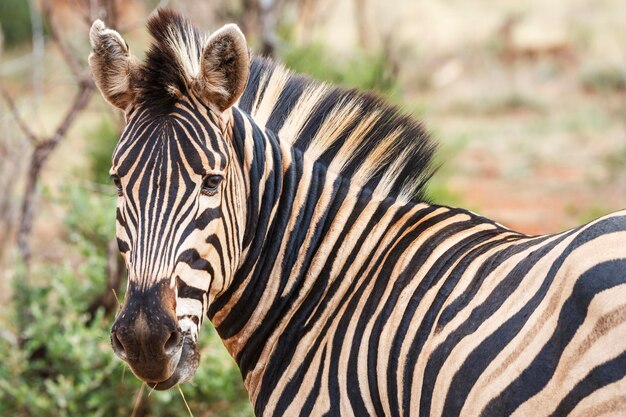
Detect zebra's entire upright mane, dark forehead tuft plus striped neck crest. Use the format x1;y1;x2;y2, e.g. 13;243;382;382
134;9;434;201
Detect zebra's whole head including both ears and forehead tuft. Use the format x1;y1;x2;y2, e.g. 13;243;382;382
89;10;250;389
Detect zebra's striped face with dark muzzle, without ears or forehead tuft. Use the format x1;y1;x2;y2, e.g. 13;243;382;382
111;98;241;388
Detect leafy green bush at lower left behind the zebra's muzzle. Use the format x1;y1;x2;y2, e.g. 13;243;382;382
0;187;252;417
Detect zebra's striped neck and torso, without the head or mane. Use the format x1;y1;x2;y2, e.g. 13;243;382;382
219;94;626;416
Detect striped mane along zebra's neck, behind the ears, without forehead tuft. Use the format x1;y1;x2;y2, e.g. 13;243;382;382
239;57;435;201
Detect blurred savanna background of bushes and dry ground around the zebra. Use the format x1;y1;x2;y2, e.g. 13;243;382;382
0;0;626;416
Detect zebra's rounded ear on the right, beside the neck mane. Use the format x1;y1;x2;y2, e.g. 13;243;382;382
193;24;250;112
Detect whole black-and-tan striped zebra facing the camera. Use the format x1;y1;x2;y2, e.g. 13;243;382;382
89;9;626;417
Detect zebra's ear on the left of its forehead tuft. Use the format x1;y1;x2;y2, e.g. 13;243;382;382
89;19;138;110
